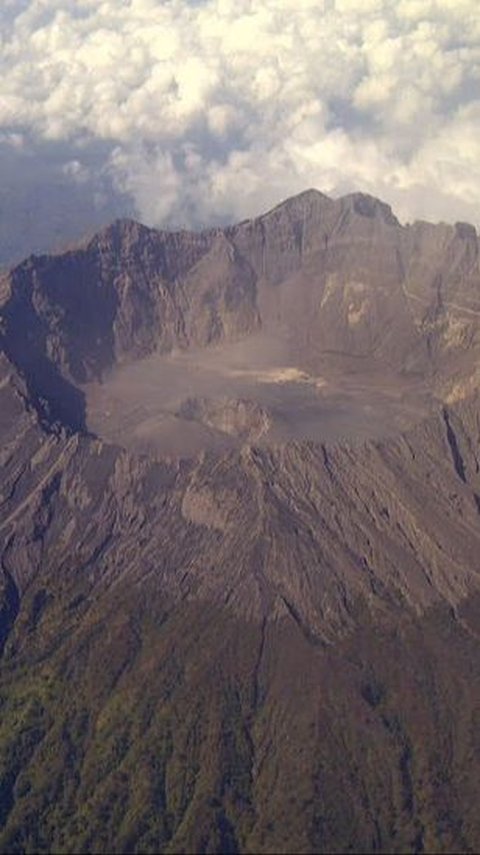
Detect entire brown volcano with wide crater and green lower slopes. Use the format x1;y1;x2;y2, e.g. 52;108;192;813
0;191;480;852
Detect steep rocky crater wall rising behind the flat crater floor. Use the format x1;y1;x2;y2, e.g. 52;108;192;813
2;191;480;402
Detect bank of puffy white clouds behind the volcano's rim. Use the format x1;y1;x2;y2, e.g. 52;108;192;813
0;0;480;241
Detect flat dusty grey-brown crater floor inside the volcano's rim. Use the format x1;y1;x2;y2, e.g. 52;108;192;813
85;335;433;456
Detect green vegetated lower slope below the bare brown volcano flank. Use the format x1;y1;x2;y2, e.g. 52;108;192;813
0;586;480;853
